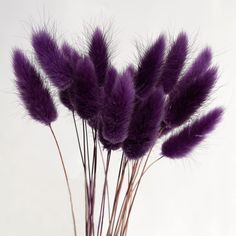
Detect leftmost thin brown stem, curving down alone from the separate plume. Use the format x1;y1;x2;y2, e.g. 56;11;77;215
49;124;77;236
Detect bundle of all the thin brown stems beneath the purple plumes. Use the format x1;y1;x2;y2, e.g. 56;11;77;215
49;112;162;236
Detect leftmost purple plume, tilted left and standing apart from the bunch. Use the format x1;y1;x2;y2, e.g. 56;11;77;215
13;49;57;125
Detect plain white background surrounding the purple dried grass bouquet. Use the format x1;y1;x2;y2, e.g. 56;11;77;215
0;0;236;236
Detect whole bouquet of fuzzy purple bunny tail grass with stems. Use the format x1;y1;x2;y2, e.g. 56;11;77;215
13;25;223;236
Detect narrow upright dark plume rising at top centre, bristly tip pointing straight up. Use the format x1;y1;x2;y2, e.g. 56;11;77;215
89;28;109;86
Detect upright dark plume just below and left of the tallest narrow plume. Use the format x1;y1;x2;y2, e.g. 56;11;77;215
71;57;102;119
